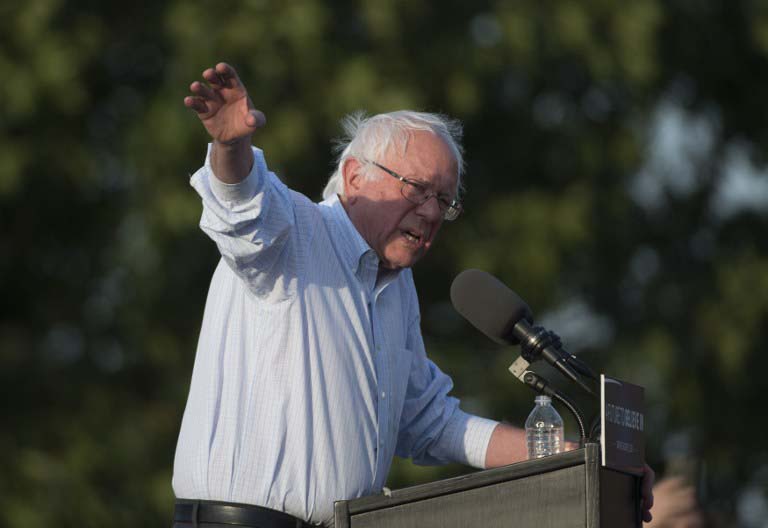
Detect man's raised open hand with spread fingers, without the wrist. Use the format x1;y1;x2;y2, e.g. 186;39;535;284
184;62;267;144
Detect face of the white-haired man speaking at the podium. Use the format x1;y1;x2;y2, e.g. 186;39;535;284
343;131;458;270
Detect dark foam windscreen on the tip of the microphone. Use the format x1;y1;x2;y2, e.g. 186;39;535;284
451;269;533;345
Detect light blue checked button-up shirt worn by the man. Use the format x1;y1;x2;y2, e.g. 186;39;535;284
173;148;497;524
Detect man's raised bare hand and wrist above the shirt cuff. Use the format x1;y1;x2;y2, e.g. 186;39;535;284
184;62;267;183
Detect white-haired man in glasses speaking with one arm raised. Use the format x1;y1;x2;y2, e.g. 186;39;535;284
173;63;652;527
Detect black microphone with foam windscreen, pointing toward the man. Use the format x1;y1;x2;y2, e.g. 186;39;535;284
451;269;595;395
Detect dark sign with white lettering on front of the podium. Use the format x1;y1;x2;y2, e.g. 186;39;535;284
600;374;645;473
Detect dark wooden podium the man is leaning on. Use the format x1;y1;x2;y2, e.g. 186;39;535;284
335;444;642;528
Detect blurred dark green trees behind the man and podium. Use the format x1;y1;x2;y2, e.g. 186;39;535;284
0;0;768;528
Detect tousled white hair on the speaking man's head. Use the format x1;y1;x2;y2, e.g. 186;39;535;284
323;110;464;199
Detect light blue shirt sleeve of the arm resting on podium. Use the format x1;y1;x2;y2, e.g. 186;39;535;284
395;319;498;468
